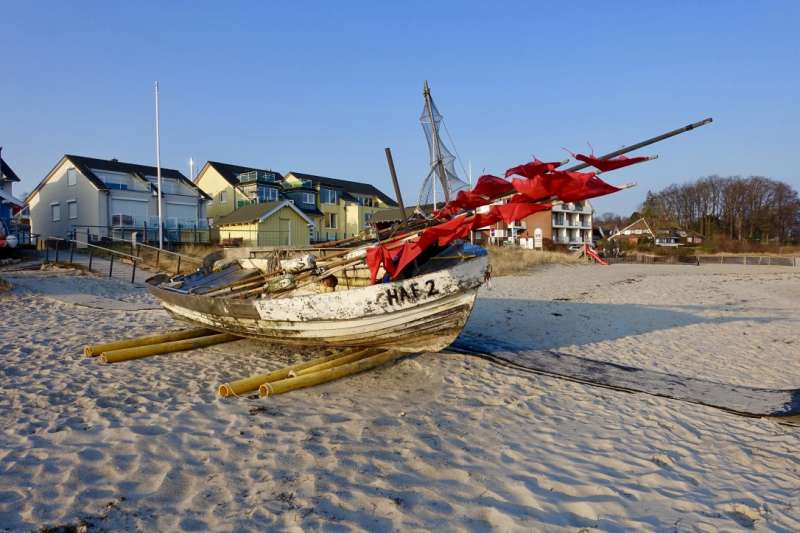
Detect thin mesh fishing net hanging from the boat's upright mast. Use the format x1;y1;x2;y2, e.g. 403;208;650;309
417;92;469;207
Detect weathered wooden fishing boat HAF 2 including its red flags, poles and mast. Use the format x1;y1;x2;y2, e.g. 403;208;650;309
149;82;711;358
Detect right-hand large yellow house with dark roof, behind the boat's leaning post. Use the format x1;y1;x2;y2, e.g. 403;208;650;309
284;171;397;241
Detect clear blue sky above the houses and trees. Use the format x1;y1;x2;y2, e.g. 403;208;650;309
0;1;800;214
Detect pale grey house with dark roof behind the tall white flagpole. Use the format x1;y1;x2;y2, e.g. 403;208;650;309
25;154;208;242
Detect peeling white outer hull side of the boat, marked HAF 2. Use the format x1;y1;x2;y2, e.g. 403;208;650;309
151;256;488;352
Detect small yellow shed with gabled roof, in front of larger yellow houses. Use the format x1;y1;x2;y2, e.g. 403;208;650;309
215;200;315;246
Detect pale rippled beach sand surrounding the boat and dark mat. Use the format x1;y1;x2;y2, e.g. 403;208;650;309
0;265;800;532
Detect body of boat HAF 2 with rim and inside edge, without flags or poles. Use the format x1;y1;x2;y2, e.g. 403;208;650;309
149;243;488;352
